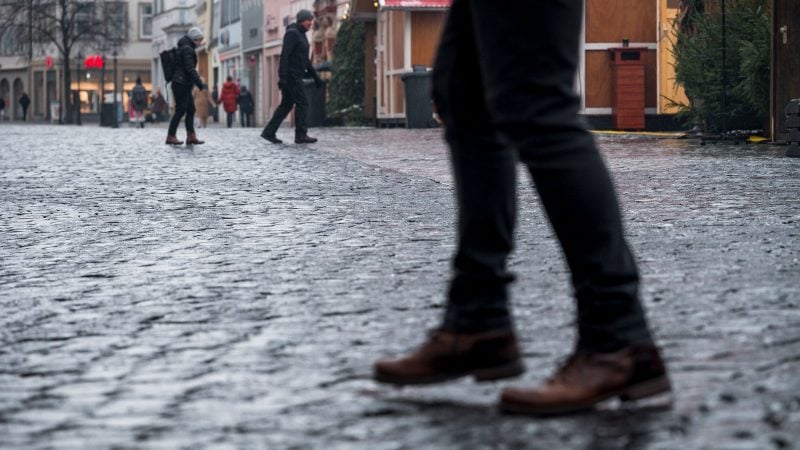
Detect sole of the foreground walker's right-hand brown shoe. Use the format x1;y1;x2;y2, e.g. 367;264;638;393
499;375;672;417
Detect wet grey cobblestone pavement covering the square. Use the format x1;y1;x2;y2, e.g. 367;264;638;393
0;125;800;450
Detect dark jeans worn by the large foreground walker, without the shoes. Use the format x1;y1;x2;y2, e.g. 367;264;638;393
440;0;652;351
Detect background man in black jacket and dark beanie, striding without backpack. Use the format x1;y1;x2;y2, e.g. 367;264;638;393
261;9;322;144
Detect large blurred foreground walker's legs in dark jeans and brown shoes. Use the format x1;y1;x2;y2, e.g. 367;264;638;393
374;0;671;415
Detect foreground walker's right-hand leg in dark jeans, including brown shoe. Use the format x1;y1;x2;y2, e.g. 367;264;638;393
462;0;670;415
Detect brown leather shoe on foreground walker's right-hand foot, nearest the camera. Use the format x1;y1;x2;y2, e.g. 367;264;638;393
500;345;671;416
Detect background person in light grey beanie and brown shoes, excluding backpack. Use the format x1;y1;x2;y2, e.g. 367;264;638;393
167;27;204;145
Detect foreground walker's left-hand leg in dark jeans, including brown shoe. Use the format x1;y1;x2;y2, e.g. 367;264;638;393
375;0;524;385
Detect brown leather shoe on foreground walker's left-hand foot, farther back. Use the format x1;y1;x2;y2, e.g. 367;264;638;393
374;330;525;385
